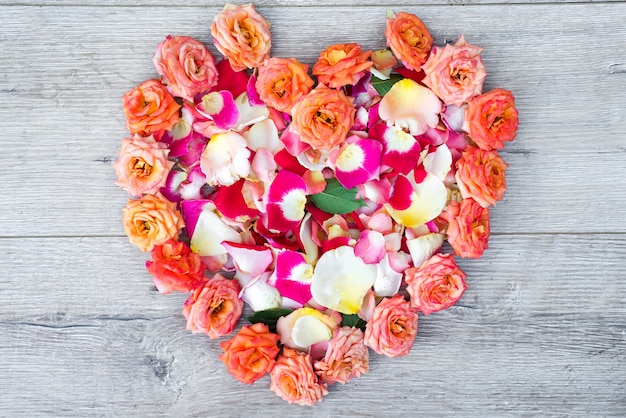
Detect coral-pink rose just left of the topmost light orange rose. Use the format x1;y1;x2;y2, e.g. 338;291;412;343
152;35;217;101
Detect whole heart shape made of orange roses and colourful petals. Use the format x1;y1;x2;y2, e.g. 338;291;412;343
114;4;518;405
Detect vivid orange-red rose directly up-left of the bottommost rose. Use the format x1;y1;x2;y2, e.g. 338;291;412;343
220;322;280;385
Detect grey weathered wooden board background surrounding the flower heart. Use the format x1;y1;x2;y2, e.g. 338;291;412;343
0;0;626;417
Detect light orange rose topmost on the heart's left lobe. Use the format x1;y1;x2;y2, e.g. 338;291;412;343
211;3;272;71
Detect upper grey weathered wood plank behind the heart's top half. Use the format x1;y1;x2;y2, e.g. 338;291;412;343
0;4;626;236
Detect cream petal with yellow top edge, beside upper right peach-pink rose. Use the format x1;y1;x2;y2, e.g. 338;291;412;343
378;78;442;135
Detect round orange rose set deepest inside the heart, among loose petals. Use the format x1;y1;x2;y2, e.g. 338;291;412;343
291;85;356;150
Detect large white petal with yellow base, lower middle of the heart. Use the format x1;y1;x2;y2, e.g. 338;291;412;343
311;246;377;314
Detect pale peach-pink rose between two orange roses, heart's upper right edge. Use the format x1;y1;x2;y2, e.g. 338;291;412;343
422;35;487;106
